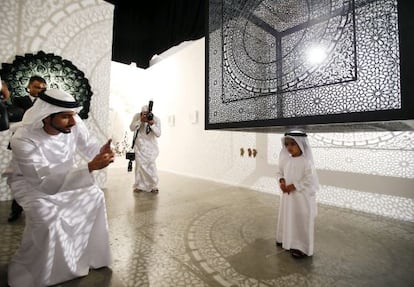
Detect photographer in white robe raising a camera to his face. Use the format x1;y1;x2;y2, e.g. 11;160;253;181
129;101;161;194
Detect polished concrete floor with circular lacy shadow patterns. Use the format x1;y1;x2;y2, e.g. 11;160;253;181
0;167;414;287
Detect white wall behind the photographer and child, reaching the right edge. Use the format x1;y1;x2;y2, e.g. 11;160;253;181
111;39;414;221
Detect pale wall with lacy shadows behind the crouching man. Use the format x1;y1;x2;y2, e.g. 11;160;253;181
0;0;113;200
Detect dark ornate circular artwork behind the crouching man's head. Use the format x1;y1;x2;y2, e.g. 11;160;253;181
0;51;92;119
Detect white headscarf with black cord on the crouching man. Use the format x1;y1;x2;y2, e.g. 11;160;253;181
21;89;82;129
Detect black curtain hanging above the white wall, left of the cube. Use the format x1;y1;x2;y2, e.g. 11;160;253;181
107;0;207;69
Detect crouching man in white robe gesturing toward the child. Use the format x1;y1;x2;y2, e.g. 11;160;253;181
8;90;114;287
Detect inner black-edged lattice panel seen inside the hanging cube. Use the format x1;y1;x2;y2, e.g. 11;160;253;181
222;0;356;102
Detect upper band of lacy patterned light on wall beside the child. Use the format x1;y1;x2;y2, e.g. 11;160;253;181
309;132;414;178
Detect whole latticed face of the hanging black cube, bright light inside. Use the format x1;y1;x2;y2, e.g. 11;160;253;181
207;0;401;124
